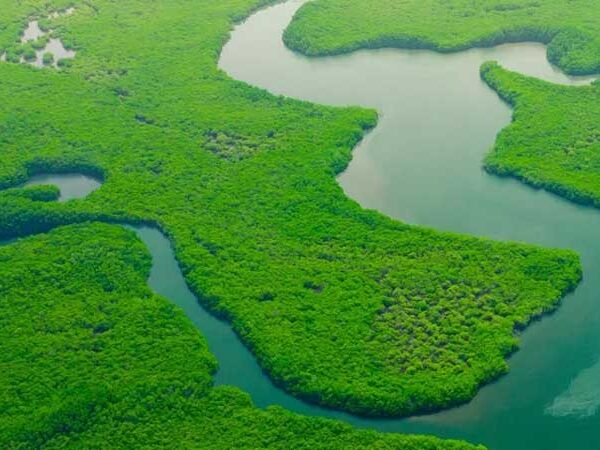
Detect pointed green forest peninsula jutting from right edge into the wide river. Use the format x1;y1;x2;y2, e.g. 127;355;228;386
481;63;600;206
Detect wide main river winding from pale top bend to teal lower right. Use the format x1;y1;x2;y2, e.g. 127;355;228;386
220;0;600;450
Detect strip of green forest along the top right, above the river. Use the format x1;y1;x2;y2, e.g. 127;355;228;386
284;0;600;74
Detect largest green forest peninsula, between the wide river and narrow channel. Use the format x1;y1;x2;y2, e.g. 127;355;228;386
0;0;580;415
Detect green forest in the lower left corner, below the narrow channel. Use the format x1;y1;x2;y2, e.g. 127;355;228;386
0;224;475;450
